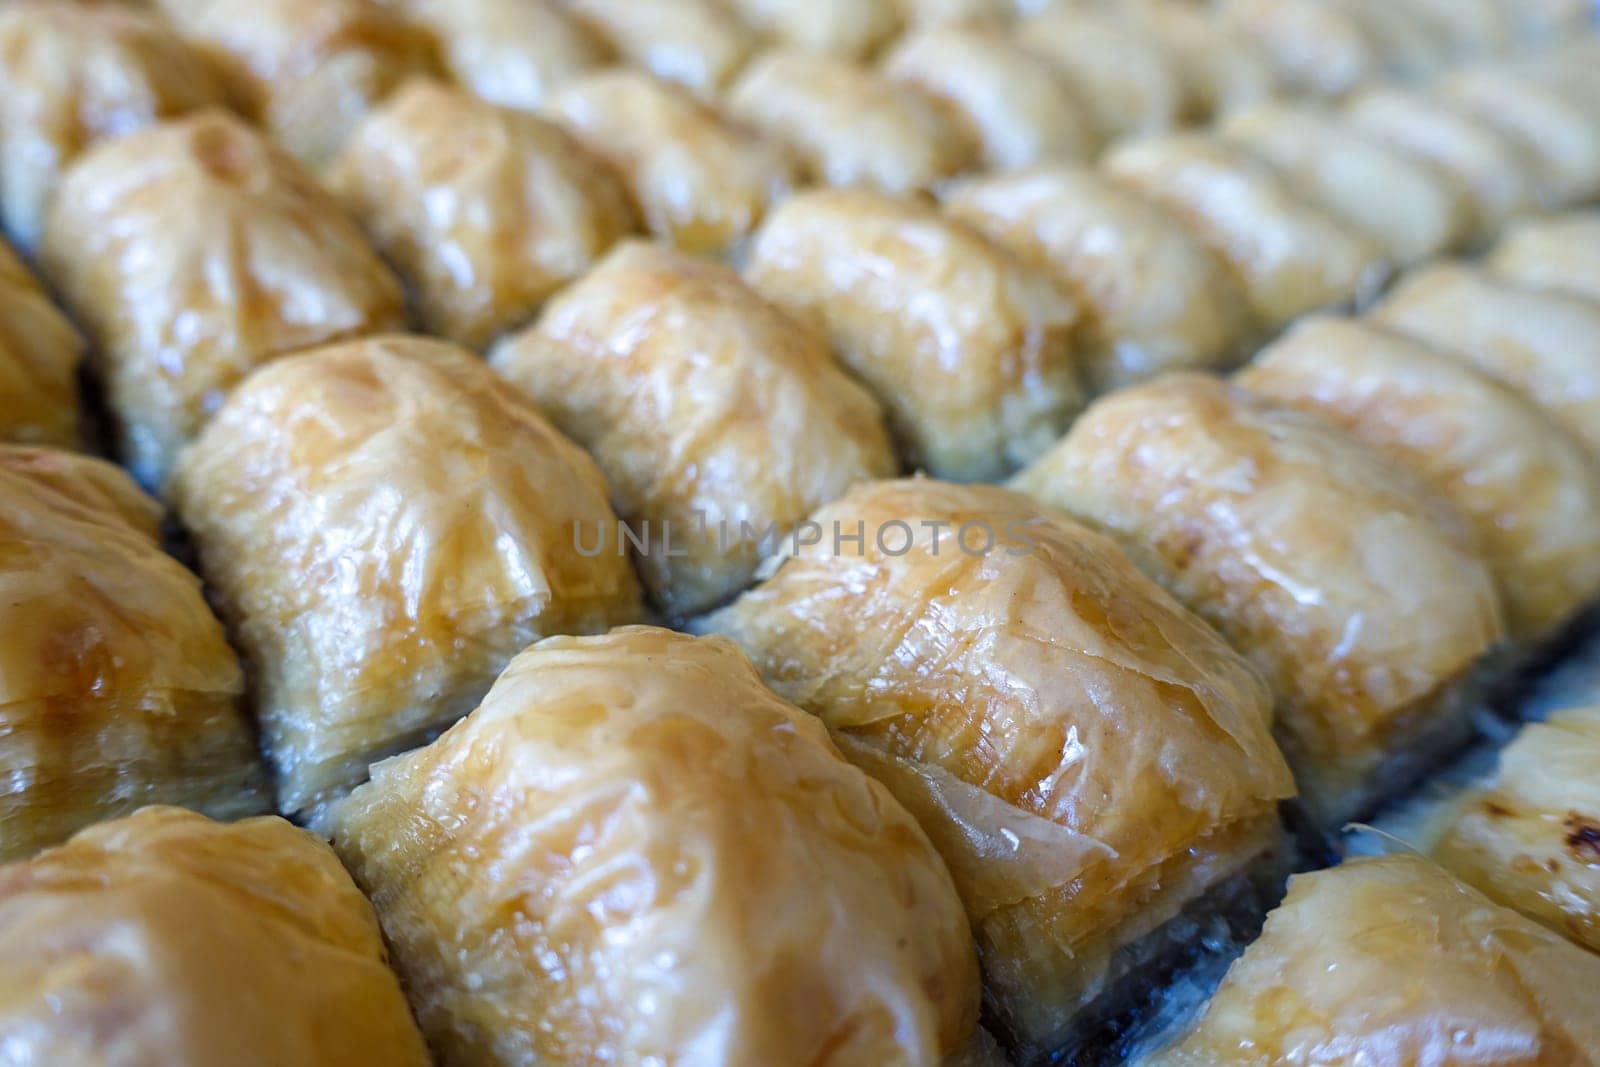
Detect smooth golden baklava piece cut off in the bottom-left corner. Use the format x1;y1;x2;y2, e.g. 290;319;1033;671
0;808;427;1067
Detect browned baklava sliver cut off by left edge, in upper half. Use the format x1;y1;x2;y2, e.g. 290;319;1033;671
0;235;83;448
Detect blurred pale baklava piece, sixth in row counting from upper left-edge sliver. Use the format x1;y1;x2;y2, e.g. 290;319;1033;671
885;26;1098;171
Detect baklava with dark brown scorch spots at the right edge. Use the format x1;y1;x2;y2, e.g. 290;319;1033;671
1430;707;1600;952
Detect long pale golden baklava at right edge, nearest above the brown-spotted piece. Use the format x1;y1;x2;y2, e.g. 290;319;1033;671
1237;318;1600;646
